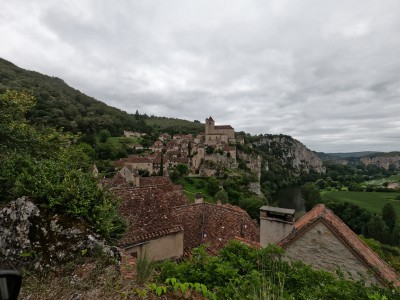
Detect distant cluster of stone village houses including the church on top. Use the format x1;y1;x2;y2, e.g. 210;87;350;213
115;116;244;177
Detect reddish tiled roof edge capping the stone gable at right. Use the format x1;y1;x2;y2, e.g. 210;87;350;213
279;204;400;286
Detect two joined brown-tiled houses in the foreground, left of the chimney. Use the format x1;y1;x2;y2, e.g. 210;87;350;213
109;173;260;260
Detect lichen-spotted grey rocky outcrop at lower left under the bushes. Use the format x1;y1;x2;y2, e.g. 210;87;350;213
0;197;119;269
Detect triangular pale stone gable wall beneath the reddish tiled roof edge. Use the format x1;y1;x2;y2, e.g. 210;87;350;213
285;221;379;284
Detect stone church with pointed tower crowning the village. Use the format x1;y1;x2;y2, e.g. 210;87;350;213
205;116;235;146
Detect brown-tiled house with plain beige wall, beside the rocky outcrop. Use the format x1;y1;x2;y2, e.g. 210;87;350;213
113;176;188;261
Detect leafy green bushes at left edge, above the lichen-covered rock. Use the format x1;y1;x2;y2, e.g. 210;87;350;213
0;91;125;238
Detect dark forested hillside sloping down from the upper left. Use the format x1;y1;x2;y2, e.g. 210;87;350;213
0;58;147;135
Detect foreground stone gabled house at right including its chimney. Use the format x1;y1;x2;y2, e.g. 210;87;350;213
260;204;400;286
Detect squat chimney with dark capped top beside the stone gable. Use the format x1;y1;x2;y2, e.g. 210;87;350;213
260;206;295;247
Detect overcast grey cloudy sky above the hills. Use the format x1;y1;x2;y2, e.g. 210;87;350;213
0;0;400;152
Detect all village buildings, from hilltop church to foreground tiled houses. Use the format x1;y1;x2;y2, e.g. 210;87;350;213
97;117;400;286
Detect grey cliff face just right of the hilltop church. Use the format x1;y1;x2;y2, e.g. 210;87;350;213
254;134;325;174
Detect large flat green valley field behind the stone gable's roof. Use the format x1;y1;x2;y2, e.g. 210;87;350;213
322;191;400;219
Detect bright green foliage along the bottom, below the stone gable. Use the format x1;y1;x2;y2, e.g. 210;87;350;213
160;241;397;299
